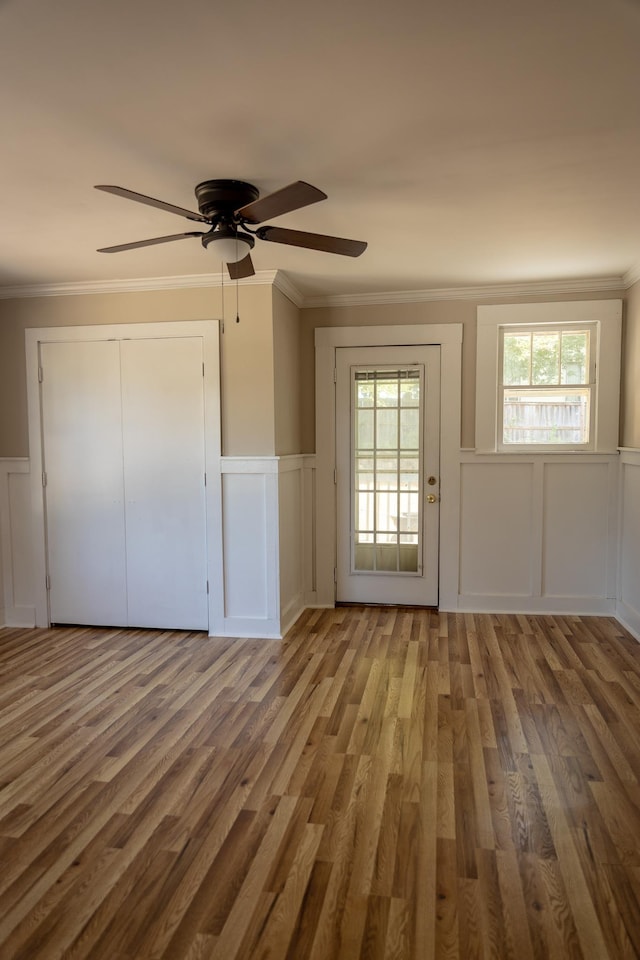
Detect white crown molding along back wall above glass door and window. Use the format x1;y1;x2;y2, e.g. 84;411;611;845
303;277;624;307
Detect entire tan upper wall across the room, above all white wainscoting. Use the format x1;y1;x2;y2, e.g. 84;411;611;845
0;283;640;457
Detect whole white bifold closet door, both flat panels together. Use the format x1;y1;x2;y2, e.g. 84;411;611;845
40;337;208;629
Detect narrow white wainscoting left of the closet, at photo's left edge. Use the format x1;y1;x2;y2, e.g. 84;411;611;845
0;458;36;627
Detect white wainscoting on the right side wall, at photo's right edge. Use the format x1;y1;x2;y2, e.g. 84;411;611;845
616;447;640;640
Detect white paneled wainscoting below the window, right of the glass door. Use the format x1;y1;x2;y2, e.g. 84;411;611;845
458;453;616;614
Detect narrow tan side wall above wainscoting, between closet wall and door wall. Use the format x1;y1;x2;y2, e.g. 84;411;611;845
273;287;302;457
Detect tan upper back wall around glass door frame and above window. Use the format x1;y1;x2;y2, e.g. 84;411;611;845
300;290;624;452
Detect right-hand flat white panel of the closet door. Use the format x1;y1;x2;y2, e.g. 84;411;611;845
121;337;209;630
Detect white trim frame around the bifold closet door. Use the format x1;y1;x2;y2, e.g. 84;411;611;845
25;320;224;636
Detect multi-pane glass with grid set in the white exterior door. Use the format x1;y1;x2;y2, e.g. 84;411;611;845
352;365;424;575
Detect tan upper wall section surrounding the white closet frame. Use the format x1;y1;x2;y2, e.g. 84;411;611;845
0;284;275;457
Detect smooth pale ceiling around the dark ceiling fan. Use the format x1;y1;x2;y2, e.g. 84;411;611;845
0;0;640;297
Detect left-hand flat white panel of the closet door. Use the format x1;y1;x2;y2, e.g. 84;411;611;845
40;340;127;626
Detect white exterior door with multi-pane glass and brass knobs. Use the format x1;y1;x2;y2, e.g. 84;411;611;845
336;346;440;606
